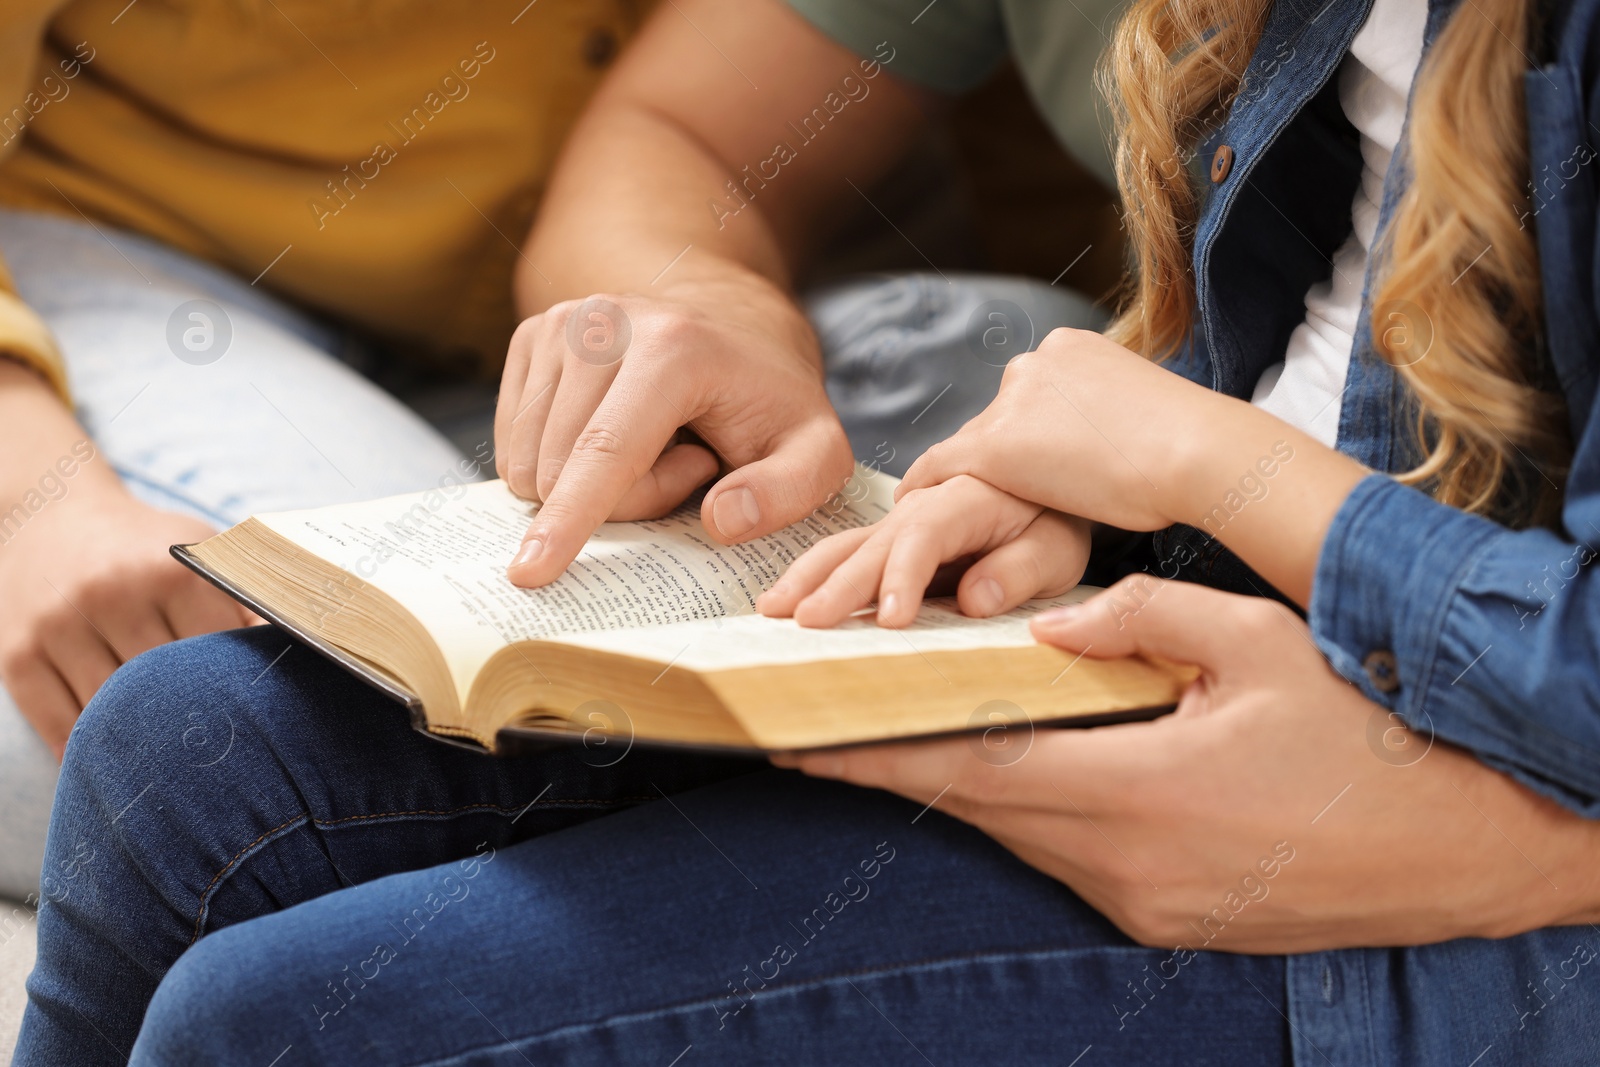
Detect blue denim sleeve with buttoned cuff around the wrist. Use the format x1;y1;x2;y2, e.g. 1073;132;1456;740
1309;475;1600;817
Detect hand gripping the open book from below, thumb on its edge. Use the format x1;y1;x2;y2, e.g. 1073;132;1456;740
776;576;1600;953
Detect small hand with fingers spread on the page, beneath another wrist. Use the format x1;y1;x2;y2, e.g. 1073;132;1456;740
755;475;1090;627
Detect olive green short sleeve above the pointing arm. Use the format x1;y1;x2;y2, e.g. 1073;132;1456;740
789;0;1010;94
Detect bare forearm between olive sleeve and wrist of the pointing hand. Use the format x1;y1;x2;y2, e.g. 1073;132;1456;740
517;0;925;321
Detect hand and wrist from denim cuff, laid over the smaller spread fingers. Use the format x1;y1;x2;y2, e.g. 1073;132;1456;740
899;330;1368;605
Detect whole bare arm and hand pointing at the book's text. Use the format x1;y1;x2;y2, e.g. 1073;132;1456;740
494;0;930;585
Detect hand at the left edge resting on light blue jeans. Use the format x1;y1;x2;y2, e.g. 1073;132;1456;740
0;479;256;758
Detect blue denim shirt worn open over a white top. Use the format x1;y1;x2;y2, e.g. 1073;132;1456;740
1158;0;1600;1067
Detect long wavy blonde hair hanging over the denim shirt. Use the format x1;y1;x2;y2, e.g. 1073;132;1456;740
1101;0;1571;525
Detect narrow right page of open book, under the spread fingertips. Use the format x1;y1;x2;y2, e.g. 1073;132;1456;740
557;585;1101;670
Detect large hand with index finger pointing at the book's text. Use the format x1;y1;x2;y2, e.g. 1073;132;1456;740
494;278;851;585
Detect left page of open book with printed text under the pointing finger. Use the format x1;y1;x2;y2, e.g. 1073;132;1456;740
256;466;898;701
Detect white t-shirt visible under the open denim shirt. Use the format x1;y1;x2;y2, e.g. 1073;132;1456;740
1250;0;1427;446
